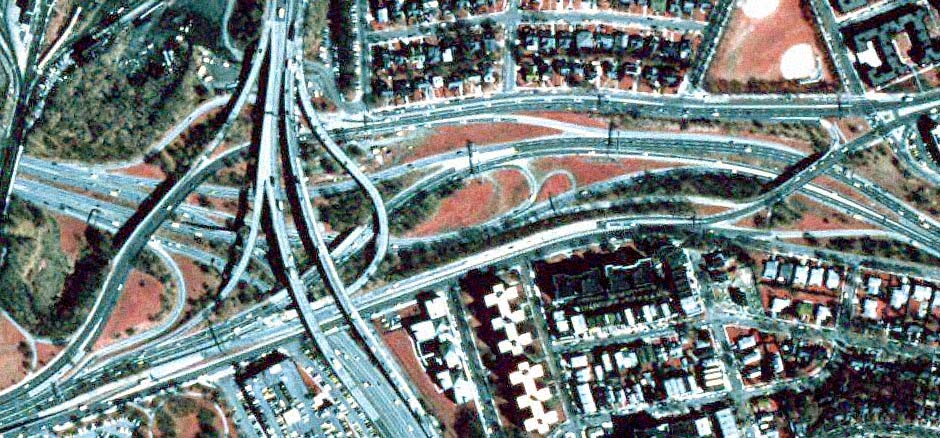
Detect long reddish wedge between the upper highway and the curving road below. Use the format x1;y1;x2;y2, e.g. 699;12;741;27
405;123;561;162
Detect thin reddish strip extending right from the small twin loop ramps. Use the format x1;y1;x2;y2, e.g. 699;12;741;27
532;156;681;187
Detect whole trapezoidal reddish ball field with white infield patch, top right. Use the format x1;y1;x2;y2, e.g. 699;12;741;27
708;0;835;92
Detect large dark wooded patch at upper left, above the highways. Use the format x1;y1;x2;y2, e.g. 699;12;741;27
27;12;204;161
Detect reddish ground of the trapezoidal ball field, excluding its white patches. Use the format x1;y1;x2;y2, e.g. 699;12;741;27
709;0;833;87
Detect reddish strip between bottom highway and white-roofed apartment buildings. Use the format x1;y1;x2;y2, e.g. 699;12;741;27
382;329;459;437
